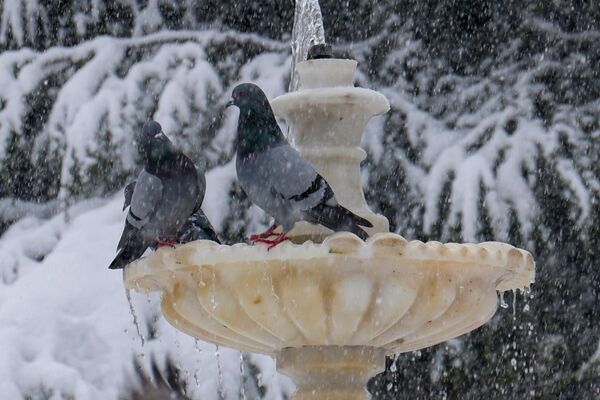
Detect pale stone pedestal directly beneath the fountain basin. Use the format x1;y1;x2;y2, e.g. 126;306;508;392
275;346;385;400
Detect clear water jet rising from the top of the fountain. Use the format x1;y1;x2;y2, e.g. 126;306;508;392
289;0;325;92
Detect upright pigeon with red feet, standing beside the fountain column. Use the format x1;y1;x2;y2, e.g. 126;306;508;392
228;83;373;248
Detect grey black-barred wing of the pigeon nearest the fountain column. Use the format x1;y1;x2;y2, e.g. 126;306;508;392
261;144;337;211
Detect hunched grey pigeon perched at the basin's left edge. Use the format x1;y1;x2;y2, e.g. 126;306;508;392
109;121;201;269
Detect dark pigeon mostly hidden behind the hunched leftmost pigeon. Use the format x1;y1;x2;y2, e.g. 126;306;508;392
123;167;221;243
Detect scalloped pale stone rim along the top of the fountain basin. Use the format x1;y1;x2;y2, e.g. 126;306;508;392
123;232;535;291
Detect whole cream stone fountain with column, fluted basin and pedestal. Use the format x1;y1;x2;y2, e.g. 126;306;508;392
124;12;535;400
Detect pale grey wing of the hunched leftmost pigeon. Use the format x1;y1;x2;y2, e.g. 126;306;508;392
117;170;163;249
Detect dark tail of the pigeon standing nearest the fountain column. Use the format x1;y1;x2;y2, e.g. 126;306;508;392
310;204;373;240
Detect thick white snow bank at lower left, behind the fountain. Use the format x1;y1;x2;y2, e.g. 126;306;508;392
0;194;293;400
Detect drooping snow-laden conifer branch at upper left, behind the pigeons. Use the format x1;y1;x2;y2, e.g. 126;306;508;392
0;31;283;197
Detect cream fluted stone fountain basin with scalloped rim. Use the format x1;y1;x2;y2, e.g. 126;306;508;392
124;233;535;356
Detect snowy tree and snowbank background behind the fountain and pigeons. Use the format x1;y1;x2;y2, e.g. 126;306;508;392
0;0;600;399
